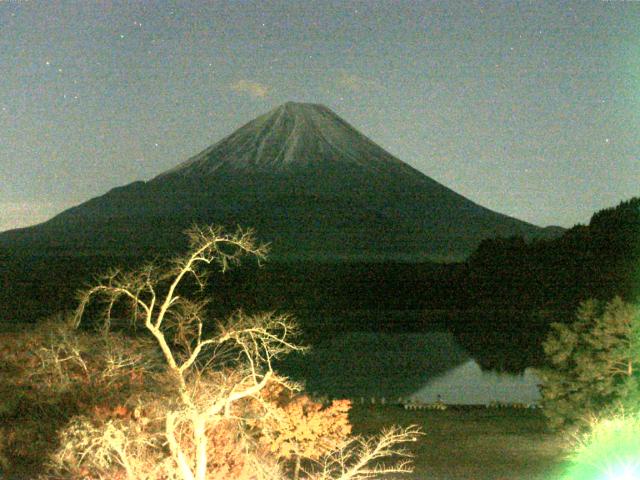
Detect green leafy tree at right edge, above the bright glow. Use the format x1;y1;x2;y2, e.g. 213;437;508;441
539;297;640;427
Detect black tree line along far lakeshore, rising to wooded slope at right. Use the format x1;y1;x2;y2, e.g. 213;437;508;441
0;198;640;371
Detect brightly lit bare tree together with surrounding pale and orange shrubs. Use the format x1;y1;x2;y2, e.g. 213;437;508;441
35;227;419;480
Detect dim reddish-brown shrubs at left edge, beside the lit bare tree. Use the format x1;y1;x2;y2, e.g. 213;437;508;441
0;318;149;478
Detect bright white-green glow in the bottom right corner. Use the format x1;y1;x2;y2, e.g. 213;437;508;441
562;414;640;480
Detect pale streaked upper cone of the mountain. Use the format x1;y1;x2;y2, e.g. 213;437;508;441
154;102;413;180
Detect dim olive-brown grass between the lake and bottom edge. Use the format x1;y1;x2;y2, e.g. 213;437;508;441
351;405;567;480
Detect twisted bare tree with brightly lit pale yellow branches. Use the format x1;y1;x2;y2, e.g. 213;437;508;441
48;227;419;480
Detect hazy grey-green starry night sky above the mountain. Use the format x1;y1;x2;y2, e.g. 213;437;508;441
0;0;640;231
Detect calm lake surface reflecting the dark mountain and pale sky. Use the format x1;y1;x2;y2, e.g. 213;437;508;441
282;329;540;404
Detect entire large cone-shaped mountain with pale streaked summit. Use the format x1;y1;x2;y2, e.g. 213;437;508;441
0;102;558;260
